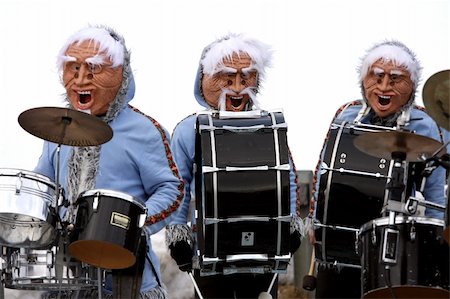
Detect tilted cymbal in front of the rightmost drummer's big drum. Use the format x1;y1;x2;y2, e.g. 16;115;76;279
353;131;446;162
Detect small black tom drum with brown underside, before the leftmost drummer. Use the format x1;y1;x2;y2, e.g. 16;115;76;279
69;189;147;269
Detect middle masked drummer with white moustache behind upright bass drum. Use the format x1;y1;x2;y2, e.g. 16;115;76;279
166;34;302;298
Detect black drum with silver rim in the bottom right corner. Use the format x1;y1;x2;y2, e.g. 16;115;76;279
359;216;450;298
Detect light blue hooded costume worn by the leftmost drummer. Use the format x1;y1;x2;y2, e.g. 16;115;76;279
35;27;184;298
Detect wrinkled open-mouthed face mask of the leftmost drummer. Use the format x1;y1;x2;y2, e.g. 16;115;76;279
63;41;123;115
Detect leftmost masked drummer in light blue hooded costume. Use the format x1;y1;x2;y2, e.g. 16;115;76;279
35;26;184;298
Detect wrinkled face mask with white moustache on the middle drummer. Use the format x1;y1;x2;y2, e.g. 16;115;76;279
202;53;258;111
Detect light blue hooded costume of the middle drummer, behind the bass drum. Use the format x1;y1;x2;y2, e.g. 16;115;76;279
166;34;304;268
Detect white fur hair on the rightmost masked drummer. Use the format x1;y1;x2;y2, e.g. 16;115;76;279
358;40;422;89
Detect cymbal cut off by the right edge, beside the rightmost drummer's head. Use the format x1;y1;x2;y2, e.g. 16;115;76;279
422;70;450;130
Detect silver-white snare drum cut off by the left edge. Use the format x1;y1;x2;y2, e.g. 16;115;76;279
0;168;56;248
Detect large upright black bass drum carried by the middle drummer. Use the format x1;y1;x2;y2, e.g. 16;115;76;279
195;111;291;275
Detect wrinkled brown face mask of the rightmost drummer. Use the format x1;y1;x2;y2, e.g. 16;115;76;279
363;60;413;118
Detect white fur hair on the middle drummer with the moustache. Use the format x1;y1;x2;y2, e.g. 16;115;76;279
200;33;273;80
